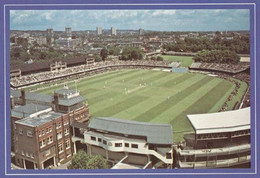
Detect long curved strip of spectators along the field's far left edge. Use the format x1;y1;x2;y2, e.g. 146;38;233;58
10;60;170;87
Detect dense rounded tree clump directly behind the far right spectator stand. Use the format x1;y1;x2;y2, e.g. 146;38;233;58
193;50;240;64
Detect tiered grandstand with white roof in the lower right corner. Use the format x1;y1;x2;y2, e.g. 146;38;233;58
176;107;251;168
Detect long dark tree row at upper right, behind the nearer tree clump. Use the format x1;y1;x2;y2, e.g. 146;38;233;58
163;36;250;54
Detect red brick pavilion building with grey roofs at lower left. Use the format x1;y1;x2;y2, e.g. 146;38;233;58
11;88;89;169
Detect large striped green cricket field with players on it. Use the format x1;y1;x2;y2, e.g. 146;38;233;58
37;69;246;141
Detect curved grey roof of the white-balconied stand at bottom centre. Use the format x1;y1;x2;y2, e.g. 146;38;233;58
89;117;173;144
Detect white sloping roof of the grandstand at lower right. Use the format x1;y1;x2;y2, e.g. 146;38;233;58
187;107;250;134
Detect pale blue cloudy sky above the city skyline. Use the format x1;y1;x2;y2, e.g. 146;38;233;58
10;9;250;31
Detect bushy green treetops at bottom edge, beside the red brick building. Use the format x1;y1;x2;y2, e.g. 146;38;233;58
68;150;108;169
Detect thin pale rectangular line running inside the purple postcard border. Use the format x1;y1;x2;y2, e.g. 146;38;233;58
4;3;257;176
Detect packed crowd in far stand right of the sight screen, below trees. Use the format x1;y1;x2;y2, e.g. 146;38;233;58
190;62;249;74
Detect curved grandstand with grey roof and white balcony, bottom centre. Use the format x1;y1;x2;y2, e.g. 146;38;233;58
84;117;173;169
